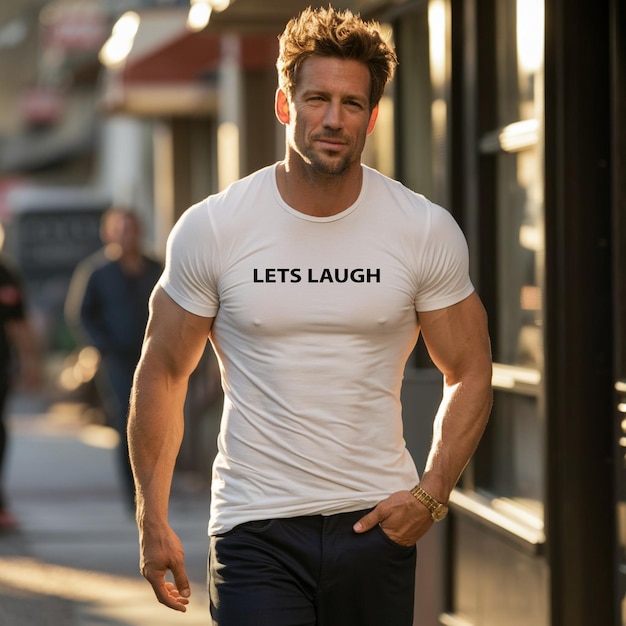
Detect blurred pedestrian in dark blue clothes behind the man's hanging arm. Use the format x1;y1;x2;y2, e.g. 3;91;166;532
71;208;163;510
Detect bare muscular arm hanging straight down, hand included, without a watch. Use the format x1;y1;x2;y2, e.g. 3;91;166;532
128;287;213;611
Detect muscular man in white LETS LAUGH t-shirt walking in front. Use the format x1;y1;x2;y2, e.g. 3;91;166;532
129;8;491;626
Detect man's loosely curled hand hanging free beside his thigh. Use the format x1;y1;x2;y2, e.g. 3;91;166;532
140;526;191;613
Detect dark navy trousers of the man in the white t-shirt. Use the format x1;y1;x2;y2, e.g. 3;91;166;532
208;511;416;626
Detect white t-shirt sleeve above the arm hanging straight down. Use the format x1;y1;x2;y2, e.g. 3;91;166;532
159;200;219;317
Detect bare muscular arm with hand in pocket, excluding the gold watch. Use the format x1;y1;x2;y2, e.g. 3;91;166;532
355;293;492;545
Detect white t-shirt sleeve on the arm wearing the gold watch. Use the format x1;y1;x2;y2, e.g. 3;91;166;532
415;202;474;312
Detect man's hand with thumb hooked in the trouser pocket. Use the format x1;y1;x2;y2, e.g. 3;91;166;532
353;491;433;546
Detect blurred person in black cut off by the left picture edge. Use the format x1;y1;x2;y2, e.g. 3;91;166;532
0;225;42;531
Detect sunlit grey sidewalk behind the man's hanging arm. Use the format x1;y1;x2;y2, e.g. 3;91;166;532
0;398;208;626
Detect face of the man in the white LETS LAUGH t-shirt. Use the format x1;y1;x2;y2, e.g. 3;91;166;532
277;56;376;176
